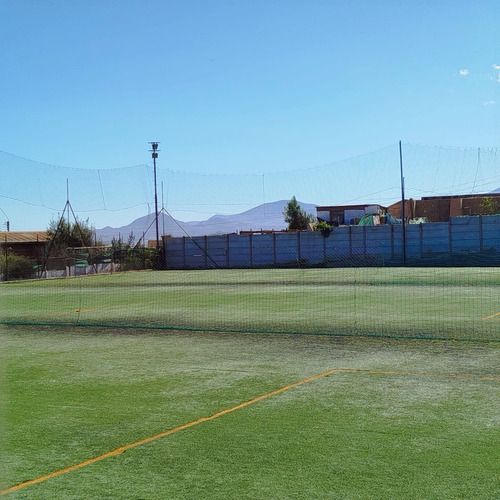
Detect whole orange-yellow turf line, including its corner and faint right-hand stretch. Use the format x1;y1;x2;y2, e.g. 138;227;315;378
0;368;500;496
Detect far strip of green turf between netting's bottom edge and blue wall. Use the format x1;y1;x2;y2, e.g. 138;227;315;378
0;268;500;340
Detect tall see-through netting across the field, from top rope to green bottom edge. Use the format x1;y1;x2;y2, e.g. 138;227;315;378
0;145;500;341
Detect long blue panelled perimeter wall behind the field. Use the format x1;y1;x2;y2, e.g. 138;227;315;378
163;215;500;269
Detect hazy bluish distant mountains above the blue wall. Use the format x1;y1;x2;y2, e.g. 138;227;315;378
96;200;317;243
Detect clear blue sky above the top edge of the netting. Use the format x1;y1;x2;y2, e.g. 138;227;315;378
0;0;500;228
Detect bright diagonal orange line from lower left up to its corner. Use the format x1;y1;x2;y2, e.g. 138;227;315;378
0;369;338;496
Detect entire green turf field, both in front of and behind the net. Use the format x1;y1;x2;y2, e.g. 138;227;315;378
0;269;500;500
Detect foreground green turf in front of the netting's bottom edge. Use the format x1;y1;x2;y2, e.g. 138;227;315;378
0;325;500;500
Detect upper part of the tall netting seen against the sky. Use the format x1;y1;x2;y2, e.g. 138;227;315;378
0;144;500;232
